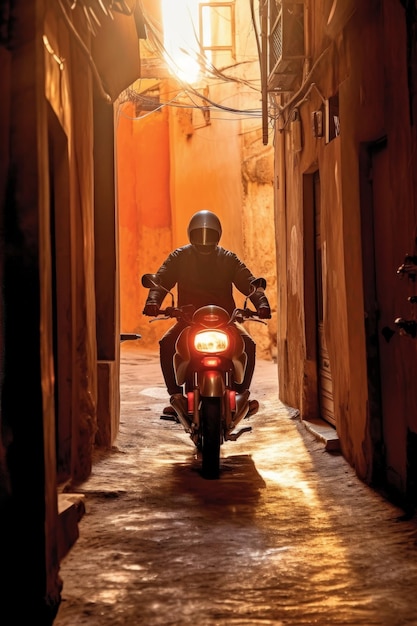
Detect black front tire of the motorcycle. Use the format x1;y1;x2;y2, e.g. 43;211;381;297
201;398;222;479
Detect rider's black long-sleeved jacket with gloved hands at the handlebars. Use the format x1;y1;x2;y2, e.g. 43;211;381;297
146;244;268;313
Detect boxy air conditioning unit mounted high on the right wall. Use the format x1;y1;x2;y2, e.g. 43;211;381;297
268;0;305;93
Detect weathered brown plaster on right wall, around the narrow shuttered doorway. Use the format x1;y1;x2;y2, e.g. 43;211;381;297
278;2;375;475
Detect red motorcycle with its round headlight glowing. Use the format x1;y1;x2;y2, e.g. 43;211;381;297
142;274;266;479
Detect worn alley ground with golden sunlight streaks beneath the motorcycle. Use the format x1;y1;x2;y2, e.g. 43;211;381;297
55;344;417;626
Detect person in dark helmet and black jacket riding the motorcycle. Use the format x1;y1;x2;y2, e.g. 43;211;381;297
143;210;271;415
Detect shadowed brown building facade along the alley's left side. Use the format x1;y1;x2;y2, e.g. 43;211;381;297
0;0;143;624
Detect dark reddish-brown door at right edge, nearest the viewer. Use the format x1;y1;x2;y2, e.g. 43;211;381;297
360;137;417;492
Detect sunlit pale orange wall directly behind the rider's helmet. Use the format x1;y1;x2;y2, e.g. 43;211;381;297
170;80;243;251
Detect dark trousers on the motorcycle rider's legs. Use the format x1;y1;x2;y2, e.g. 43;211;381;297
159;322;256;396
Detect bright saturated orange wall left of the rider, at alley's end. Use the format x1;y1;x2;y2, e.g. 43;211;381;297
117;102;172;332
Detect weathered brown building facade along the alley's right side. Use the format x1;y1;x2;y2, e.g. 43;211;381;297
264;0;417;509
